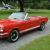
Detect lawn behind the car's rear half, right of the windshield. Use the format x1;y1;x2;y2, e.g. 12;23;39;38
28;9;50;19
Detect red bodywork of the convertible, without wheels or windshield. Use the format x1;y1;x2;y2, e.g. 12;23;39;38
0;16;48;38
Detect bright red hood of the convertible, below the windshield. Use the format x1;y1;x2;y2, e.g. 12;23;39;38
0;19;21;26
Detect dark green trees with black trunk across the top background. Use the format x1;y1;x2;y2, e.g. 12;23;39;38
0;0;50;9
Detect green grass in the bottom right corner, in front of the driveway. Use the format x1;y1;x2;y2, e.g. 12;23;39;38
18;35;50;50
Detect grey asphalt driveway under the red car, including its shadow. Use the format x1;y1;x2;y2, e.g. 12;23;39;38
0;21;50;50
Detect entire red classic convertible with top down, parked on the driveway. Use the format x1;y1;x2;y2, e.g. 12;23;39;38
0;12;48;42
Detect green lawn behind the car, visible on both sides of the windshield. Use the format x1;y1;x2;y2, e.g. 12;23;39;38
0;9;50;19
